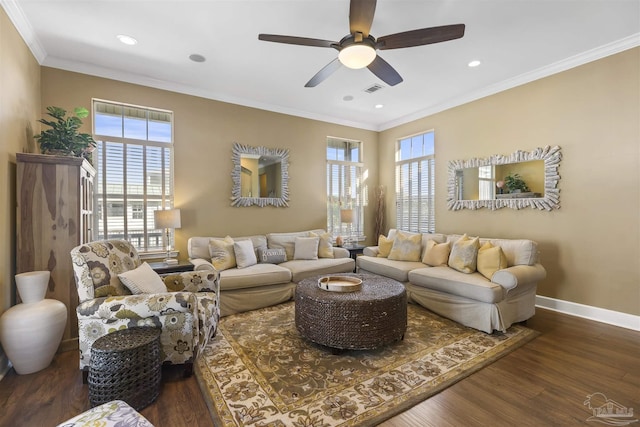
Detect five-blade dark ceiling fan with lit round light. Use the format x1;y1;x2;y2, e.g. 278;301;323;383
258;0;464;87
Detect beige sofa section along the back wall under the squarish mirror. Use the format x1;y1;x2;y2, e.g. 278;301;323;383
187;230;355;316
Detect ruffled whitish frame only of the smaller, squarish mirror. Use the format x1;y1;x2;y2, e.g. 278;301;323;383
231;142;289;207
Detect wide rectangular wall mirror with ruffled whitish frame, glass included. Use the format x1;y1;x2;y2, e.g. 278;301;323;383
447;145;562;211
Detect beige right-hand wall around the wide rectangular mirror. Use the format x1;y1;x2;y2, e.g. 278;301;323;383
379;48;640;315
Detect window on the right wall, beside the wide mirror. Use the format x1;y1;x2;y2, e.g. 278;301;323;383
396;131;436;233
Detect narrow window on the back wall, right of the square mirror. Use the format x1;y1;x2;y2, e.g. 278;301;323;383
327;137;366;241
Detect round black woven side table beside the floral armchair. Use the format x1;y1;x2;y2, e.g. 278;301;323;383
88;327;162;410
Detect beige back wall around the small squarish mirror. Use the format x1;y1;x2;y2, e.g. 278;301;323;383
42;67;378;258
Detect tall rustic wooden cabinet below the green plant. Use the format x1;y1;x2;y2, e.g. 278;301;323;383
16;153;96;351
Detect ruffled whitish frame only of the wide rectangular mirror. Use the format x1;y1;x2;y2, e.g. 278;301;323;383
447;145;562;211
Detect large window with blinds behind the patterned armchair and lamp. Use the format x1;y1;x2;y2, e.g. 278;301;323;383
93;100;173;253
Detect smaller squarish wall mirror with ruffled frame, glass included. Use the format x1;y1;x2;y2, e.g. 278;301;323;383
231;143;289;207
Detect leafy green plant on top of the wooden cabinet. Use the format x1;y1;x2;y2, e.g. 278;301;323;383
34;106;96;159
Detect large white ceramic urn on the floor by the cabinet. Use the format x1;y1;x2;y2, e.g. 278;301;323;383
0;271;67;375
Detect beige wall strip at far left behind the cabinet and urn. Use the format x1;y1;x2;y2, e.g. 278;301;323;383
0;8;40;374
